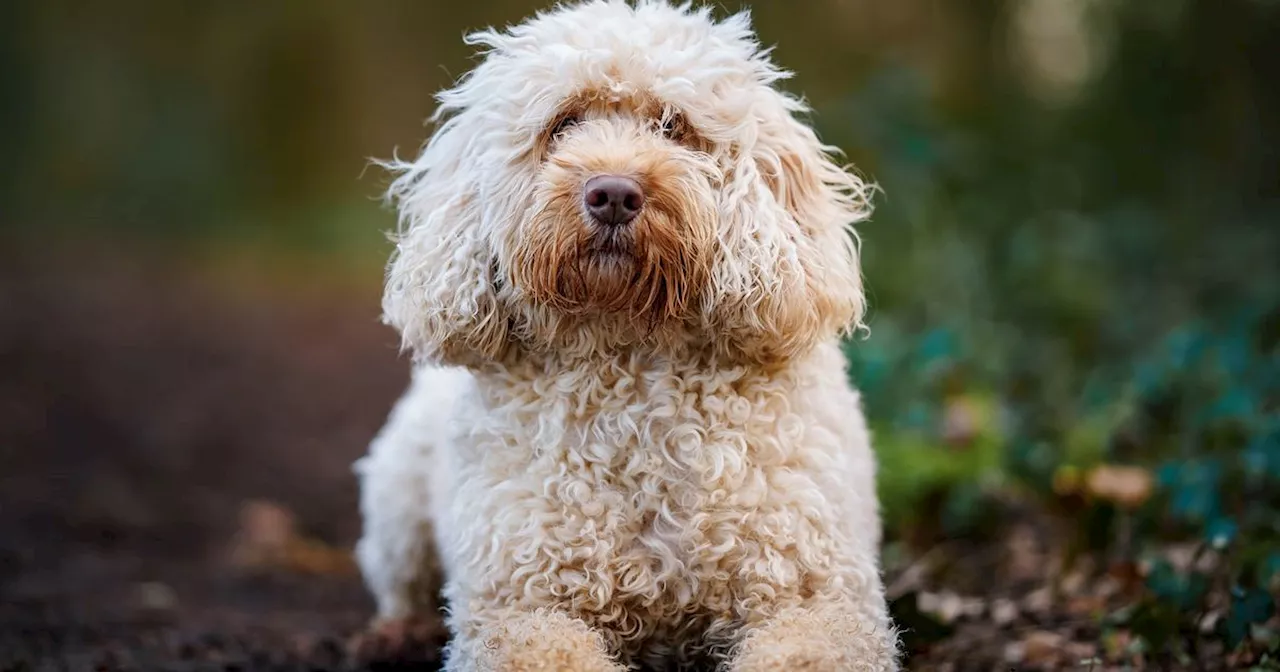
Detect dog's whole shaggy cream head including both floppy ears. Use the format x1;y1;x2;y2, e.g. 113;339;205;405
383;0;869;364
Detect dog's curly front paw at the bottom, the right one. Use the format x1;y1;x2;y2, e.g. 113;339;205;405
727;603;899;672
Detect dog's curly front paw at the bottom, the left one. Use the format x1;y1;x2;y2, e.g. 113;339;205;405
444;608;626;672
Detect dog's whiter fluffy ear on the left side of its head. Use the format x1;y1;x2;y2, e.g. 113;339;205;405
383;111;508;365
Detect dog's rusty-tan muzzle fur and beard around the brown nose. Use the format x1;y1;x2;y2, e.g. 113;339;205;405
512;167;714;324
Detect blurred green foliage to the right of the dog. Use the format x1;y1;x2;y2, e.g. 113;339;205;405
824;1;1280;660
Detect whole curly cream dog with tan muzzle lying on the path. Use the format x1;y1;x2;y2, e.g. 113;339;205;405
356;0;900;672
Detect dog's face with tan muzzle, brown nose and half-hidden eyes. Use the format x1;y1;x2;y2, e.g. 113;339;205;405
514;84;719;326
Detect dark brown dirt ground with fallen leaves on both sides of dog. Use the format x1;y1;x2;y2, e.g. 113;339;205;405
0;243;1254;671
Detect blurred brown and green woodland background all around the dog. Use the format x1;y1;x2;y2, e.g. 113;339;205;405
0;0;1280;669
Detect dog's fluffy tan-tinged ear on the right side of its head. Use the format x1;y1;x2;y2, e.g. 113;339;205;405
723;92;872;362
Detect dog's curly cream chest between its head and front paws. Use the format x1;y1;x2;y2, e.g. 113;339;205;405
457;360;838;650
